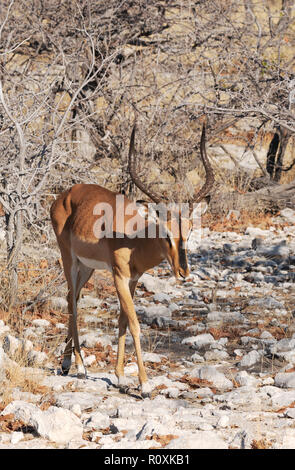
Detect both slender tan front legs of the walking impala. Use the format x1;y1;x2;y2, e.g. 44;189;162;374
114;275;151;397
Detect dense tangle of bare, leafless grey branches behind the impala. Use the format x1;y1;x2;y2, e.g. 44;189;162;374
0;0;295;302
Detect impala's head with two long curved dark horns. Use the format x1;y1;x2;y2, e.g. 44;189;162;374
129;125;214;279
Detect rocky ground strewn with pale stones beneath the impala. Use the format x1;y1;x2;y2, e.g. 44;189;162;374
0;210;295;449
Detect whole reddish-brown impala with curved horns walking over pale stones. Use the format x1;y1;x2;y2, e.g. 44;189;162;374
50;125;214;397
